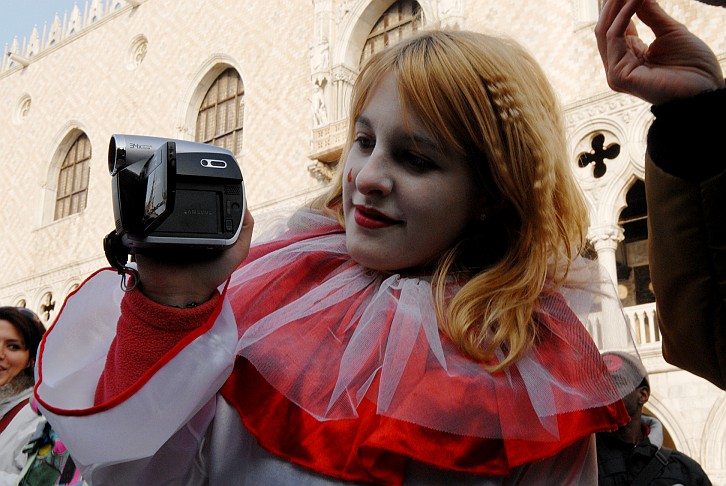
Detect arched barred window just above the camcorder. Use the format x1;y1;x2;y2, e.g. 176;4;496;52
194;68;245;154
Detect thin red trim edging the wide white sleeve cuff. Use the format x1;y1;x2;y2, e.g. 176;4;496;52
35;268;229;416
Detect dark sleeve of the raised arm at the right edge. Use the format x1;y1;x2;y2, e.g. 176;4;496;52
645;90;726;389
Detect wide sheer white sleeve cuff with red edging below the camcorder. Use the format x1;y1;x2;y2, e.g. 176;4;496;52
36;269;237;479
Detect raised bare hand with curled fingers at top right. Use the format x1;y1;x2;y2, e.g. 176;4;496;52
595;0;724;105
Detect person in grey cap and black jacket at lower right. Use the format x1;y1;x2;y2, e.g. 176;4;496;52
597;351;711;486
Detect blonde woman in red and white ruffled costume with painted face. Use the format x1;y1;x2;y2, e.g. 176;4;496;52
36;30;632;486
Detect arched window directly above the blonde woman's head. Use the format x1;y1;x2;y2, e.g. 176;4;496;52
360;0;424;64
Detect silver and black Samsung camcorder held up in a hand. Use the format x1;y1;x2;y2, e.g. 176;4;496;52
104;134;245;271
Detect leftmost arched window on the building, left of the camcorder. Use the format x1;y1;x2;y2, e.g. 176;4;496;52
53;134;91;220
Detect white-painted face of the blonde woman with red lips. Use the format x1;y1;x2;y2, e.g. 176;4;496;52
343;75;482;271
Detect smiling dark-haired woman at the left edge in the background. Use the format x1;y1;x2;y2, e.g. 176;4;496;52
0;307;45;486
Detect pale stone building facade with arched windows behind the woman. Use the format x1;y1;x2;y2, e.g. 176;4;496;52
0;0;726;485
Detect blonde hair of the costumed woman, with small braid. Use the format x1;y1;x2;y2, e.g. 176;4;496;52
317;31;588;371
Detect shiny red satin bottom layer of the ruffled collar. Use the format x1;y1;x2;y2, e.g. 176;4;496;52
220;358;627;484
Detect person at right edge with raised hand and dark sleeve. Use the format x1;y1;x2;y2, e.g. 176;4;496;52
595;0;726;389
